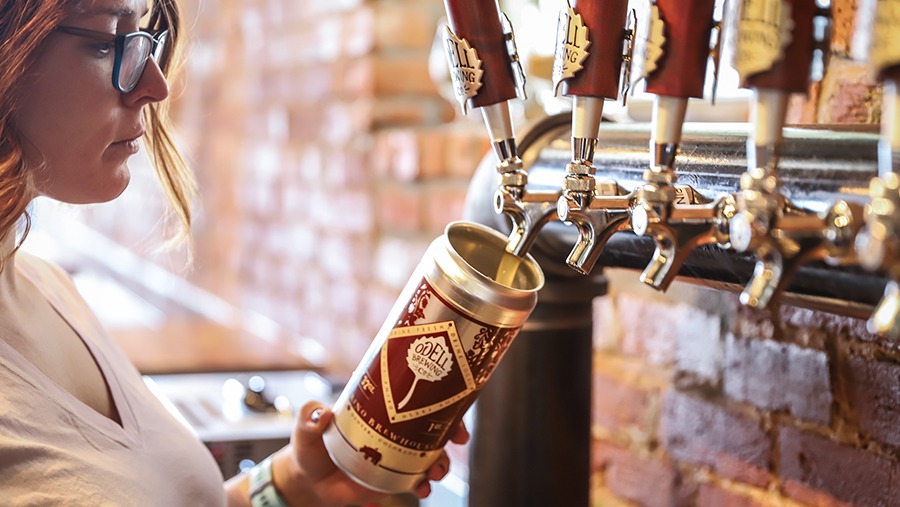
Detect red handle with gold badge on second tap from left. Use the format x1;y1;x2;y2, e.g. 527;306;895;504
553;0;628;99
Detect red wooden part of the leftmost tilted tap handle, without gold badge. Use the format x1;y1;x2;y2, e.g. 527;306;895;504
444;0;516;107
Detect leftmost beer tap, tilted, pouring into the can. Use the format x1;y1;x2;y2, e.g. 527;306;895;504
444;0;557;256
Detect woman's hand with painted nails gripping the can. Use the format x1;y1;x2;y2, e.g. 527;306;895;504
272;402;469;507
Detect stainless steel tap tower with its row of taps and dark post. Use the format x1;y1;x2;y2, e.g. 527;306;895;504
436;0;900;507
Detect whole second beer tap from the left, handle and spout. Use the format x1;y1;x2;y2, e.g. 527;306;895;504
553;0;633;274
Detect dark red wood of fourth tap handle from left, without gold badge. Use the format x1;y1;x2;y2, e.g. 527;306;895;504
743;0;818;93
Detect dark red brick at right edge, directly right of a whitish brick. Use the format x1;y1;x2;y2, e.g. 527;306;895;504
843;356;900;447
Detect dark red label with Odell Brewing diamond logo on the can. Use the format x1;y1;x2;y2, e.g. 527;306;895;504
349;279;518;451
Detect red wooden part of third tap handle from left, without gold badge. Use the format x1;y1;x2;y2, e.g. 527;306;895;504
645;0;716;98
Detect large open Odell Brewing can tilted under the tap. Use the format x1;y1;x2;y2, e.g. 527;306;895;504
324;222;544;493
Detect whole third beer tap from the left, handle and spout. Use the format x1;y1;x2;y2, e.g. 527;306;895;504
631;0;734;291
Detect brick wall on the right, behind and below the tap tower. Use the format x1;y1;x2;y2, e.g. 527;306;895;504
592;0;900;507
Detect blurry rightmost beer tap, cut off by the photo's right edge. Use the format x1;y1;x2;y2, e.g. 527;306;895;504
854;0;900;340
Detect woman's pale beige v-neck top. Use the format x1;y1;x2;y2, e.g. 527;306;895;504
0;251;225;507
